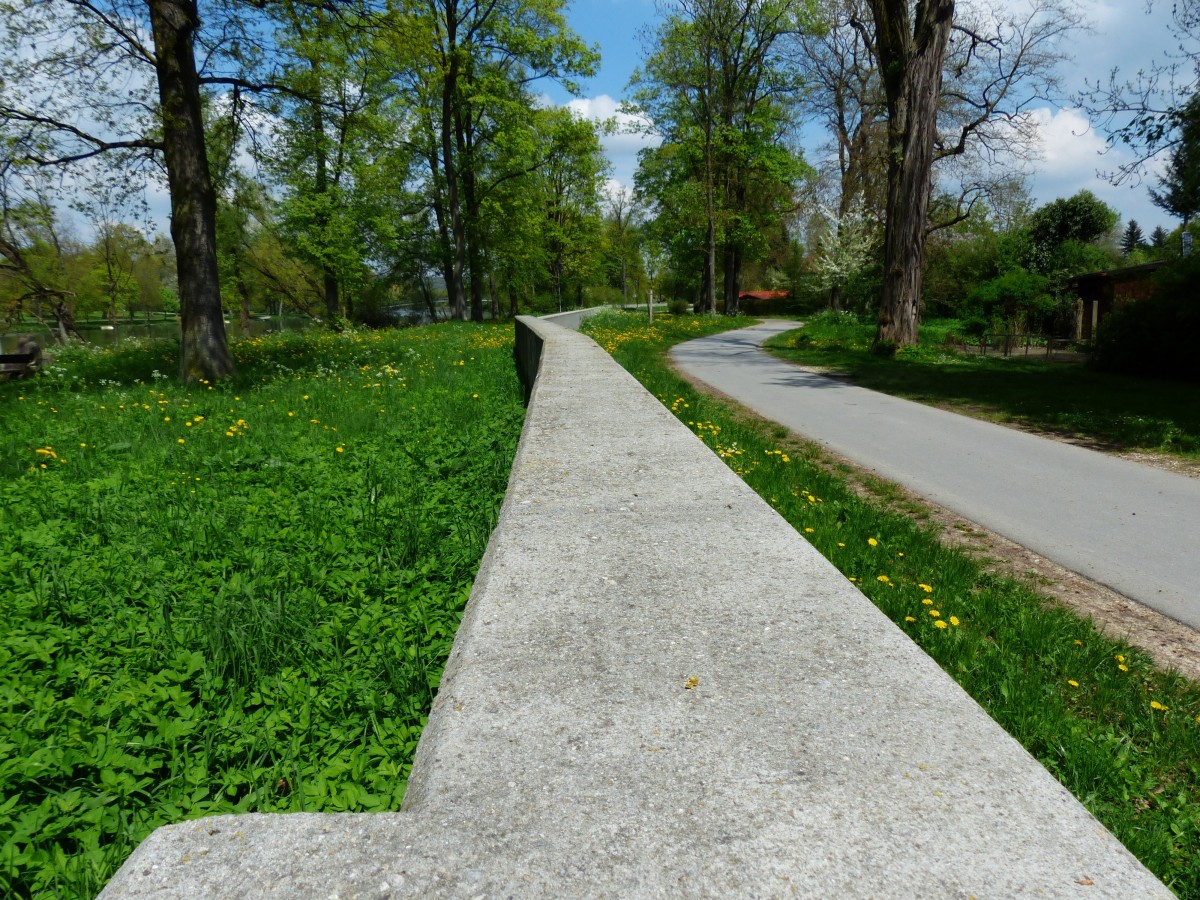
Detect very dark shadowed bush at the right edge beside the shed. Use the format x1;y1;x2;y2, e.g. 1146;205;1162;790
1092;257;1200;382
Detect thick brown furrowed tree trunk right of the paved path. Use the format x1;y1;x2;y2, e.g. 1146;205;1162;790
871;0;954;347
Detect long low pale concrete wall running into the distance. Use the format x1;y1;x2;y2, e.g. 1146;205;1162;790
103;319;1170;899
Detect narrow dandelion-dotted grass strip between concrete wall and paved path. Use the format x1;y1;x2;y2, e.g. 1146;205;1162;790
584;316;1200;898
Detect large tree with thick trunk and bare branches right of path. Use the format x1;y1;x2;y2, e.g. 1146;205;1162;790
858;0;1080;346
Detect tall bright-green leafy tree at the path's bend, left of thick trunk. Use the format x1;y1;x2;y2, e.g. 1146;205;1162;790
628;0;809;313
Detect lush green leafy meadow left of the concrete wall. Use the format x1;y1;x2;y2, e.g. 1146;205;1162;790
0;325;523;896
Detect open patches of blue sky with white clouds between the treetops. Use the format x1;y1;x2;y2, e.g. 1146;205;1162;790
544;0;1177;234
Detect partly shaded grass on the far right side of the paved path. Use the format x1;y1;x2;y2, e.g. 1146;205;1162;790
767;312;1200;461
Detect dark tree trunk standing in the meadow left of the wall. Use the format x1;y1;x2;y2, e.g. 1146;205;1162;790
149;0;234;382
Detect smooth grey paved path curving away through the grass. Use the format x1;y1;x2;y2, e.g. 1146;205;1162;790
671;320;1200;629
